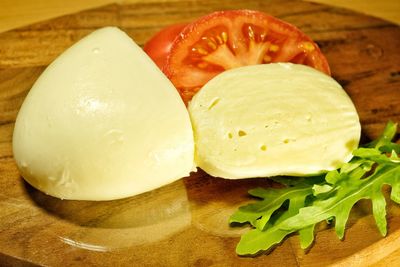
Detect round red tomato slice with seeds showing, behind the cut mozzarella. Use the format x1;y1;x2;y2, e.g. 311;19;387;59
163;10;330;103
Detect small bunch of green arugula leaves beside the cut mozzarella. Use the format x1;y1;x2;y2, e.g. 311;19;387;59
230;122;400;255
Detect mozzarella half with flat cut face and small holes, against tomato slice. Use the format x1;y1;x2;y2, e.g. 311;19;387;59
189;63;361;179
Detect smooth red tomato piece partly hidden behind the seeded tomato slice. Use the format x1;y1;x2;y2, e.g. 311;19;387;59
143;23;187;70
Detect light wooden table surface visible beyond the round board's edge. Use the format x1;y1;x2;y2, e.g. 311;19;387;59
0;0;400;266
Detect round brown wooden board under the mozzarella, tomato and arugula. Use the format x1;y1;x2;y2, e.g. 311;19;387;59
0;0;400;266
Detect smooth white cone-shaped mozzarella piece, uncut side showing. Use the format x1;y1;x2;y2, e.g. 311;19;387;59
13;27;194;200
